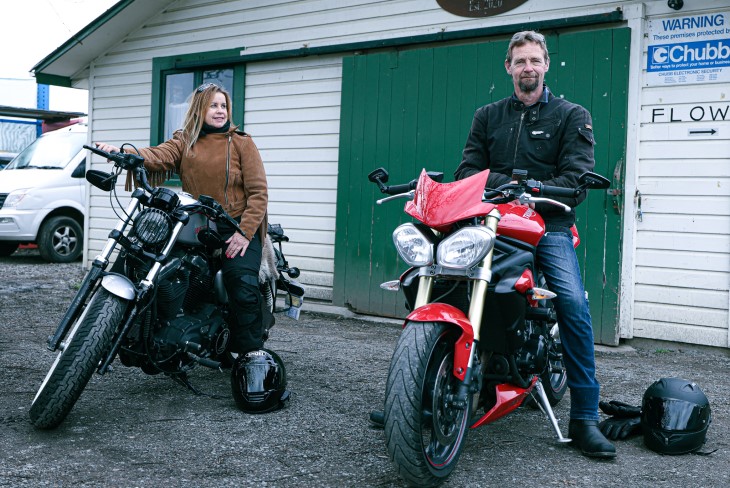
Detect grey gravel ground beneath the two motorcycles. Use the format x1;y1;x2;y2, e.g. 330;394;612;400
0;250;730;487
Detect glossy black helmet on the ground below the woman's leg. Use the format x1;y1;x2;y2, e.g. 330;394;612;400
231;349;289;413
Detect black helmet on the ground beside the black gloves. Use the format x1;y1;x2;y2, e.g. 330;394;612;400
641;378;712;454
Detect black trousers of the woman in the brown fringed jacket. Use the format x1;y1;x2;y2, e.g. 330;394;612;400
218;224;264;354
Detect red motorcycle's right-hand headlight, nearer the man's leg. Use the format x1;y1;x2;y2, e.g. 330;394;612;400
436;226;494;268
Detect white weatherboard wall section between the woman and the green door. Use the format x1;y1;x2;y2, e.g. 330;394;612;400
244;56;342;300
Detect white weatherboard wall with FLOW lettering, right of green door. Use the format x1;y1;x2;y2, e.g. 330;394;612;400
625;2;730;347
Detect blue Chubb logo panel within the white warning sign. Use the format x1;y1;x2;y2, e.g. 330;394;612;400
649;39;730;71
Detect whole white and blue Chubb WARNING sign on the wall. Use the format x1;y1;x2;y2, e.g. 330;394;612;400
646;12;730;86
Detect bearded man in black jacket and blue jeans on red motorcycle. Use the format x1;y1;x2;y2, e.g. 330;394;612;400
455;31;616;459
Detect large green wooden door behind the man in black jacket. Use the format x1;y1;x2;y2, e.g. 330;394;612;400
333;29;629;344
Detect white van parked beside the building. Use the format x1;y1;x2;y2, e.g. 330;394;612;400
0;123;88;263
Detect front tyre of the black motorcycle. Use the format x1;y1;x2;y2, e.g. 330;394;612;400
30;288;127;429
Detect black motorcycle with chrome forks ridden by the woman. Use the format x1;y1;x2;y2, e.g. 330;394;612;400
30;146;304;429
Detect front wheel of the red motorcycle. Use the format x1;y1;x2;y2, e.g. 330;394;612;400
385;322;472;486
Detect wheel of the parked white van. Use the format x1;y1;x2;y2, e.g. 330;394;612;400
38;215;84;263
